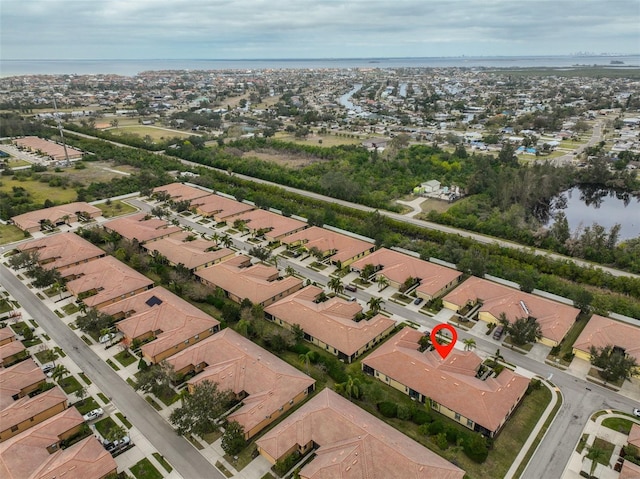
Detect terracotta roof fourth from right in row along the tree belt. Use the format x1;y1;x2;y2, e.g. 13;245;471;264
282;226;374;262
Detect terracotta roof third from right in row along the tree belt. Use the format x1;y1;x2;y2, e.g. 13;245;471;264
351;248;462;296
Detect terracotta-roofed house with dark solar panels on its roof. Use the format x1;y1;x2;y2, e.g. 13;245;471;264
115;287;220;364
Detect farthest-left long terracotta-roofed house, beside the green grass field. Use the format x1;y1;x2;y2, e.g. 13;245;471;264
11;202;102;233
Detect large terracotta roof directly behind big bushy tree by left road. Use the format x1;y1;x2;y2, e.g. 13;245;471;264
167;329;315;432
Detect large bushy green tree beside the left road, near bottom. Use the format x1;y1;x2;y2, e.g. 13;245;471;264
169;380;234;436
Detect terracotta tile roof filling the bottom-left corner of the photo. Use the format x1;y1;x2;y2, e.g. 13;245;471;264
0;408;117;479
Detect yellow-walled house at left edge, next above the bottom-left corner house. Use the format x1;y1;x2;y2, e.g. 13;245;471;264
0;386;67;442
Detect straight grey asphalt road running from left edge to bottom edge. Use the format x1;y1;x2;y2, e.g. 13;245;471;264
0;264;225;479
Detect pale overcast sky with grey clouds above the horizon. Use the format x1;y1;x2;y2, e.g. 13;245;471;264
0;0;640;60
